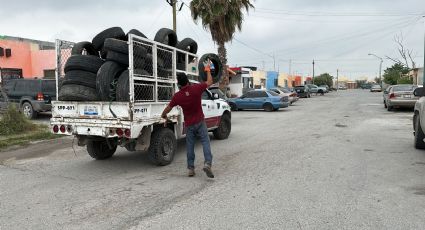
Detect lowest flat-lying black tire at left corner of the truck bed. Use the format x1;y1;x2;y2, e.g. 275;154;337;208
59;85;99;101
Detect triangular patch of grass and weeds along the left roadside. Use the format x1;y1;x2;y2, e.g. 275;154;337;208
0;106;61;150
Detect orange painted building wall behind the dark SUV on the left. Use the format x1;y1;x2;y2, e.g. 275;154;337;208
0;39;55;78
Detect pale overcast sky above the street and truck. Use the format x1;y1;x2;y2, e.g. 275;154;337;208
0;0;425;79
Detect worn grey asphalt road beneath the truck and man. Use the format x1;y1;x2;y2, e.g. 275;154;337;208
0;90;425;230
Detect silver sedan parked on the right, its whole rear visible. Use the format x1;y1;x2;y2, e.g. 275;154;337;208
384;85;419;111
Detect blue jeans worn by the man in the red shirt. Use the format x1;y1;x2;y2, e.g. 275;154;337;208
186;121;212;169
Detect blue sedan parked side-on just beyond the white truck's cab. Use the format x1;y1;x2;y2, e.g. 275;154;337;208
225;90;289;112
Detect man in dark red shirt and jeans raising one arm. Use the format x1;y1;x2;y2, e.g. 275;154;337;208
161;61;214;178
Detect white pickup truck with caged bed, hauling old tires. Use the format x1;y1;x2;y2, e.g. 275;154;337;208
51;35;231;165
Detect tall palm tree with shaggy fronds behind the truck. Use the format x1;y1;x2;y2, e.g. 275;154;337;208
190;0;254;86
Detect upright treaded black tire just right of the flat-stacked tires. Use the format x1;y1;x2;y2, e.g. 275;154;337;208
96;61;127;101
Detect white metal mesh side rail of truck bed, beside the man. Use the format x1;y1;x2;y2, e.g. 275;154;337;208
129;35;198;103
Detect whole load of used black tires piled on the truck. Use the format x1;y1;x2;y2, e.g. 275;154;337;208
59;27;223;101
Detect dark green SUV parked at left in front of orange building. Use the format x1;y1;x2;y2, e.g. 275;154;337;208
3;79;56;119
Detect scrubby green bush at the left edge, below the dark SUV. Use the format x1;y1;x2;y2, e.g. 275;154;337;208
0;105;37;135
